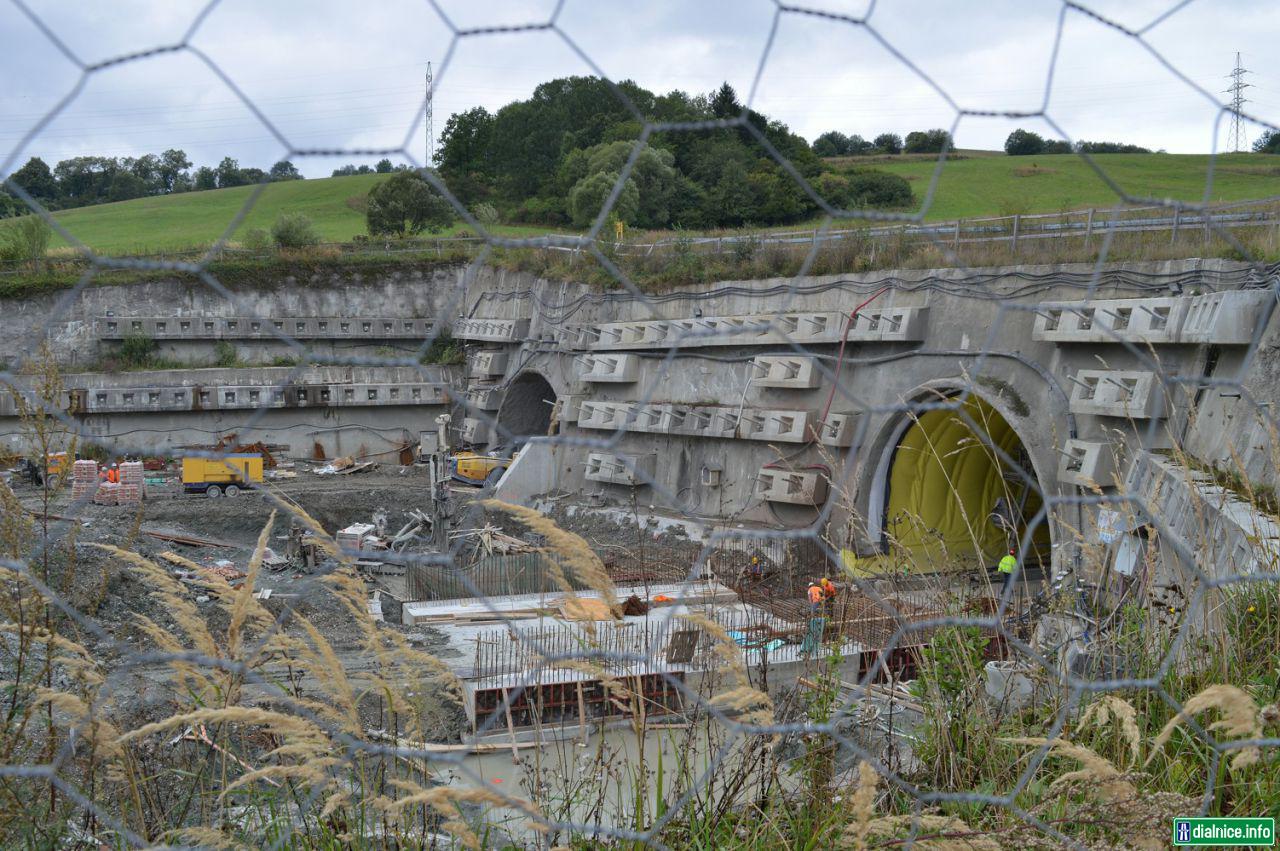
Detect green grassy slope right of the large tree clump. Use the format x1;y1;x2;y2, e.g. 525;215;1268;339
870;154;1280;220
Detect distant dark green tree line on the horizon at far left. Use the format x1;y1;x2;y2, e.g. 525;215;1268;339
0;148;302;218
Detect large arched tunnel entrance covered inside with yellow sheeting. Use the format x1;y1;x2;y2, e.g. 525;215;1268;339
858;395;1051;573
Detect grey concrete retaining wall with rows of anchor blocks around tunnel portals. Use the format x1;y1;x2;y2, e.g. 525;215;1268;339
0;260;1280;591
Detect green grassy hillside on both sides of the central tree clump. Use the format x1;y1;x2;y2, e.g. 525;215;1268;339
27;151;1280;255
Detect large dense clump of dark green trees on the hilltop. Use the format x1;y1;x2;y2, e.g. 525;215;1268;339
436;77;911;229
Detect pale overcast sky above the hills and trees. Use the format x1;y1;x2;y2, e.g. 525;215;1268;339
0;0;1280;177
